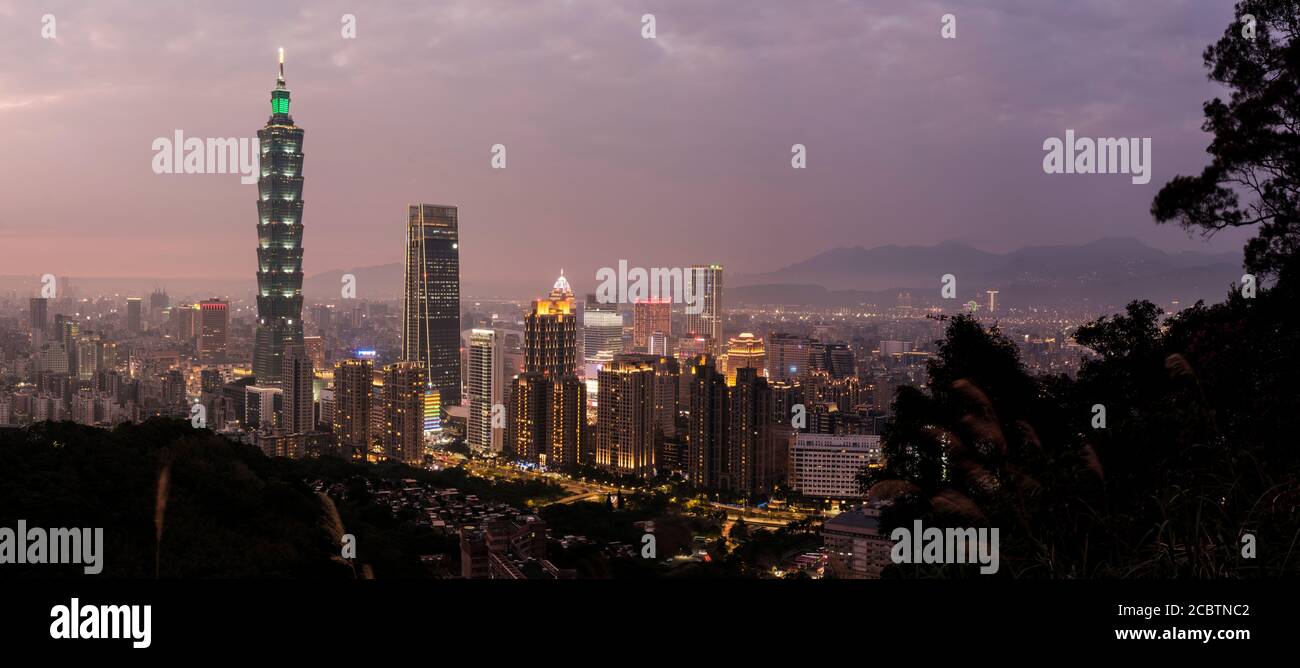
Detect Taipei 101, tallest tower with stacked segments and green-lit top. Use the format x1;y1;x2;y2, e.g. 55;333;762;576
252;49;303;387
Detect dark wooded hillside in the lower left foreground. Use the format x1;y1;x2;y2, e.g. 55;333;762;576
0;418;563;578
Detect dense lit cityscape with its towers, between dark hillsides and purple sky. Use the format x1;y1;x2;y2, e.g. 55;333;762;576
0;53;1112;578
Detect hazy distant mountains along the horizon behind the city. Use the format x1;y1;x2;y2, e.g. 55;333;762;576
0;238;1243;307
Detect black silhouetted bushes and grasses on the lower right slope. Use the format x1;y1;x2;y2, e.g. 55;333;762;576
863;276;1300;577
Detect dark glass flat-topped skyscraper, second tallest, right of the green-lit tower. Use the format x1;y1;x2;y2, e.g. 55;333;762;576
402;204;460;407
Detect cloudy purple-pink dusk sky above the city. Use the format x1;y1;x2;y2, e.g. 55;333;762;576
0;0;1248;291
